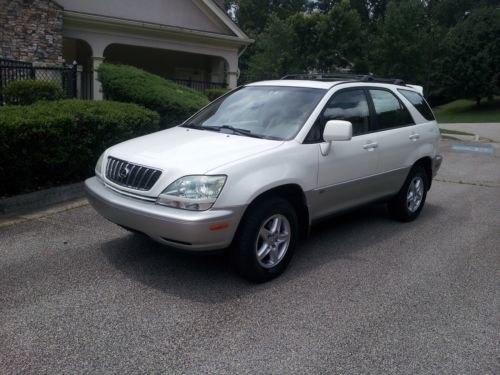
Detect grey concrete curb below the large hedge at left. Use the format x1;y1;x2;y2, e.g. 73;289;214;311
0;182;85;217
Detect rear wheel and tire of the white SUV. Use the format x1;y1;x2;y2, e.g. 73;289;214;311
388;165;429;222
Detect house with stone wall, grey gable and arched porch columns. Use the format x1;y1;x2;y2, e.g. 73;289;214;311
0;0;252;99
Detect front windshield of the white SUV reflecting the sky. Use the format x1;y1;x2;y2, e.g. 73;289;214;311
182;86;326;140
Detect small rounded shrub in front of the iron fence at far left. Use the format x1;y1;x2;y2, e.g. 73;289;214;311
2;79;63;105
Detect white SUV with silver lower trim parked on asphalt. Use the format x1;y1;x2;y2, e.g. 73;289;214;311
85;78;441;281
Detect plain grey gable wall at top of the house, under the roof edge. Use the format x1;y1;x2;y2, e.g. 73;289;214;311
57;0;234;35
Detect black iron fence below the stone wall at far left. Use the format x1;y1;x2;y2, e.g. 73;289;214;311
0;59;78;103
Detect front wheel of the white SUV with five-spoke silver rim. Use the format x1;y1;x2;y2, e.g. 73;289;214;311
232;197;298;283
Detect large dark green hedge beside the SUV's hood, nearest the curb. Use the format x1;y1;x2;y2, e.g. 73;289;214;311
0;100;159;197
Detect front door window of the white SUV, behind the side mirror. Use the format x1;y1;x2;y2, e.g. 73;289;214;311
323;90;370;135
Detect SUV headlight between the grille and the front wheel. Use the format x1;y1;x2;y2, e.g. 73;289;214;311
156;176;227;211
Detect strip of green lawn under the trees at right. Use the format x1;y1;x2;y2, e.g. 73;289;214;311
434;96;500;123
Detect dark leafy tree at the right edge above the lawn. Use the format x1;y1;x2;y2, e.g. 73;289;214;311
440;7;500;105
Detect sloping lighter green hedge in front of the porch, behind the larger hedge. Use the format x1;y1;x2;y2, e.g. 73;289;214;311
97;64;208;128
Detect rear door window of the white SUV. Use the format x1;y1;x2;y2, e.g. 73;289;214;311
369;89;415;130
